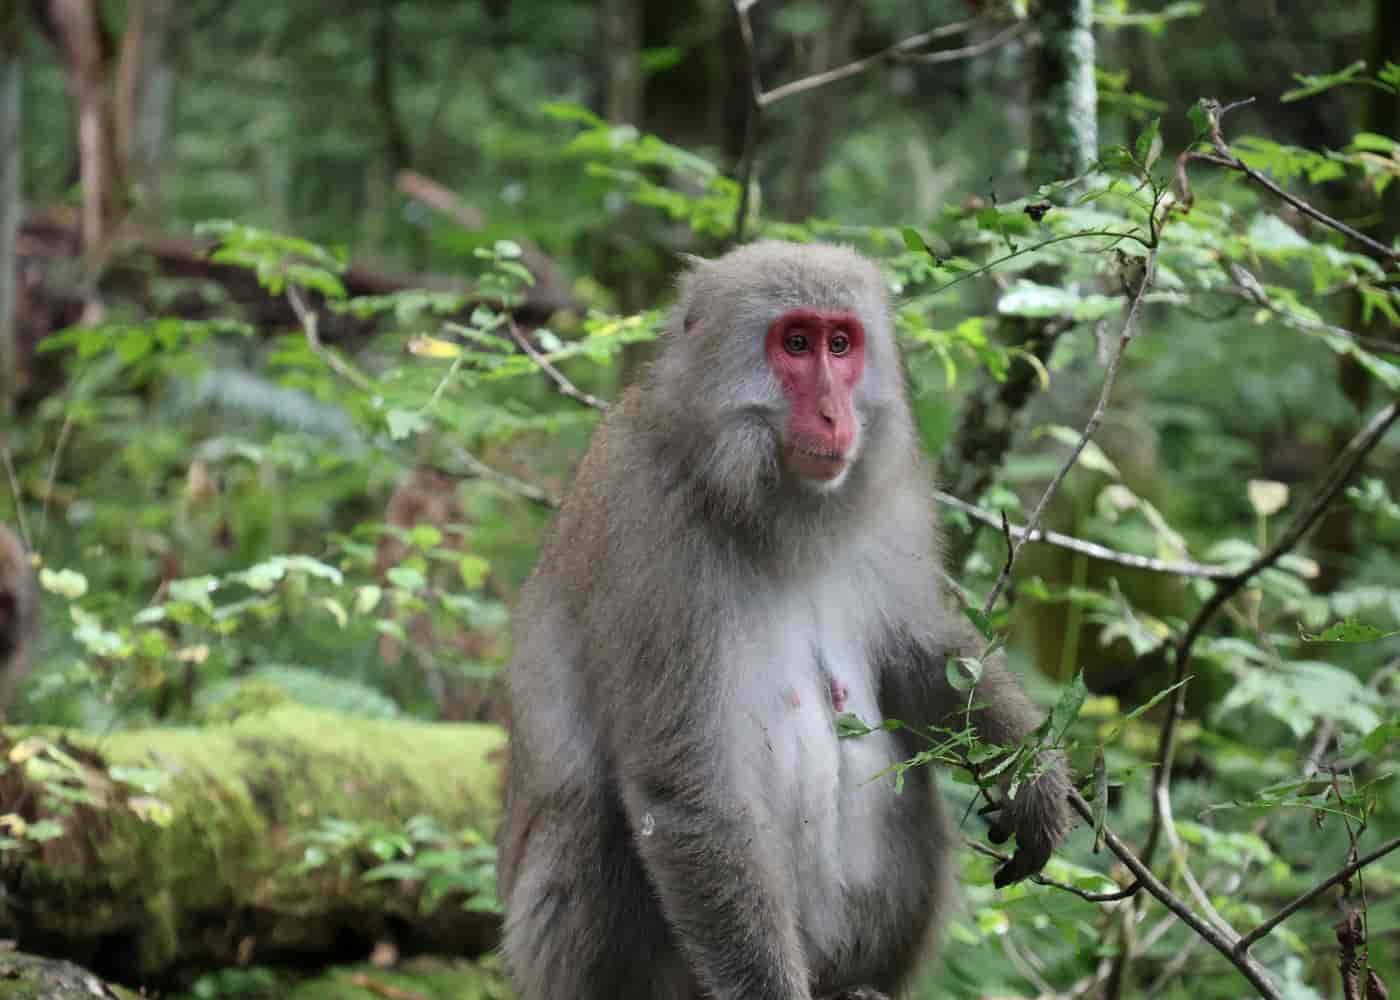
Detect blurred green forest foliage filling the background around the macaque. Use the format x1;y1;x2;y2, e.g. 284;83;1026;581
0;0;1400;1000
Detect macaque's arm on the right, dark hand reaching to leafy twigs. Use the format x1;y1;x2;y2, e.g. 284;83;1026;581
882;627;1072;888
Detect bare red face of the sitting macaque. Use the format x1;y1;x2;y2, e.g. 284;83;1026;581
764;310;865;483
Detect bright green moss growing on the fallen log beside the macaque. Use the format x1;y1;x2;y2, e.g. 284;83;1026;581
0;704;505;973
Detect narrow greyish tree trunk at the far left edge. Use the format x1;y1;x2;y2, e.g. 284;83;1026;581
0;0;24;417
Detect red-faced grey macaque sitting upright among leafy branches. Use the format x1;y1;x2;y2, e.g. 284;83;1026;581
500;242;1070;1000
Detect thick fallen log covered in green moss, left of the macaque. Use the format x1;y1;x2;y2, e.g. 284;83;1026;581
0;706;505;985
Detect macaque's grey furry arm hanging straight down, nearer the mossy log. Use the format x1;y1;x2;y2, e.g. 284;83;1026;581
620;709;811;1000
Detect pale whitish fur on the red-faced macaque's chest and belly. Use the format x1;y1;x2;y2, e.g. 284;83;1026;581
725;560;911;951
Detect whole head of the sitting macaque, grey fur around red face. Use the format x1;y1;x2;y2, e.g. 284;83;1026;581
651;242;909;513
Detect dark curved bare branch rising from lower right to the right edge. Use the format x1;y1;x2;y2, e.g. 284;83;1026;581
1142;401;1400;861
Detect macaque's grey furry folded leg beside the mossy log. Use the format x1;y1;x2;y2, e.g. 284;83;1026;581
503;796;701;1000
